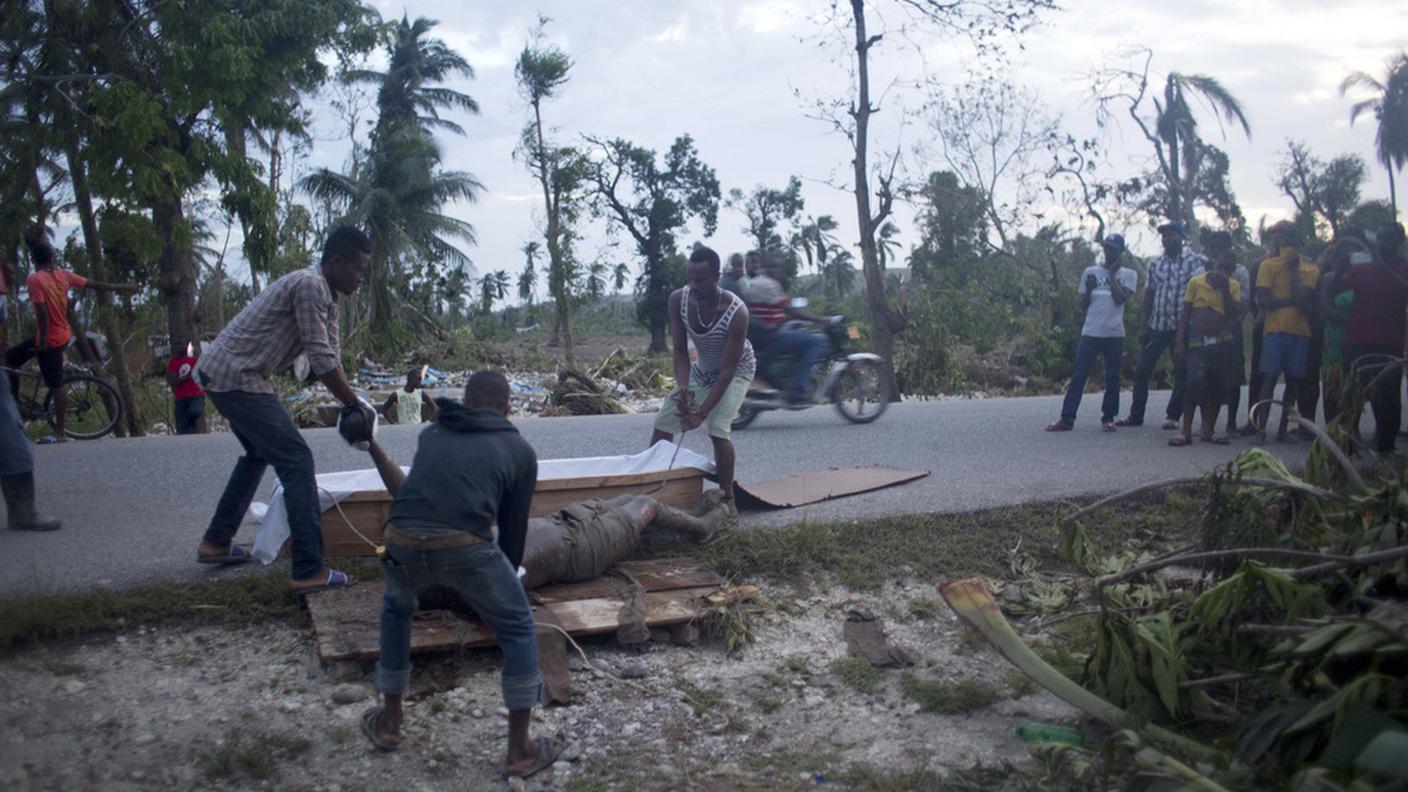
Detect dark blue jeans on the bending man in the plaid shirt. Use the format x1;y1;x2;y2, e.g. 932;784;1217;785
206;390;322;578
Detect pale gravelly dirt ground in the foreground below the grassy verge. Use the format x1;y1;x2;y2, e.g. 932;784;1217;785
0;572;1079;792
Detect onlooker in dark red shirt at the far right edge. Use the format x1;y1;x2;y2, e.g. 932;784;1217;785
1339;223;1408;455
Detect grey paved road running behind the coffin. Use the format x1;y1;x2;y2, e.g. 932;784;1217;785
0;393;1305;593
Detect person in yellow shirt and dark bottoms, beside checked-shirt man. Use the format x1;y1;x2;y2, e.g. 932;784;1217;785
1169;246;1243;445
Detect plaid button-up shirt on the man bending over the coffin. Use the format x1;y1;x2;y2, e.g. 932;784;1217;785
196;264;342;393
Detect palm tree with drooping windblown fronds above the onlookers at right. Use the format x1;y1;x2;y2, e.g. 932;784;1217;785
1153;72;1252;237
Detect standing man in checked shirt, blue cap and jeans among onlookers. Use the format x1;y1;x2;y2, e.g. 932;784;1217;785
1115;220;1208;428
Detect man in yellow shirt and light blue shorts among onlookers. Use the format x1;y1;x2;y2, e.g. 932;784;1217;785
1252;220;1319;445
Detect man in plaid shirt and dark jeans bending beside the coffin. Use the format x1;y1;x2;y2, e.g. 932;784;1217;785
196;225;372;593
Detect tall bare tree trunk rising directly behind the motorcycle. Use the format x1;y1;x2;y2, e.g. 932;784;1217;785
850;0;904;400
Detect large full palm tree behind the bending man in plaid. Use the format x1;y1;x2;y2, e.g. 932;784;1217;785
300;17;482;344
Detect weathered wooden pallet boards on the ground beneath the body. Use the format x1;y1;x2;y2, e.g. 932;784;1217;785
308;558;724;661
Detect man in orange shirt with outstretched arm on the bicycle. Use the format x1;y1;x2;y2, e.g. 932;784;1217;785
4;241;141;443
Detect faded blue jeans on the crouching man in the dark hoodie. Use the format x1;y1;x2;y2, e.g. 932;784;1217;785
376;543;542;710
